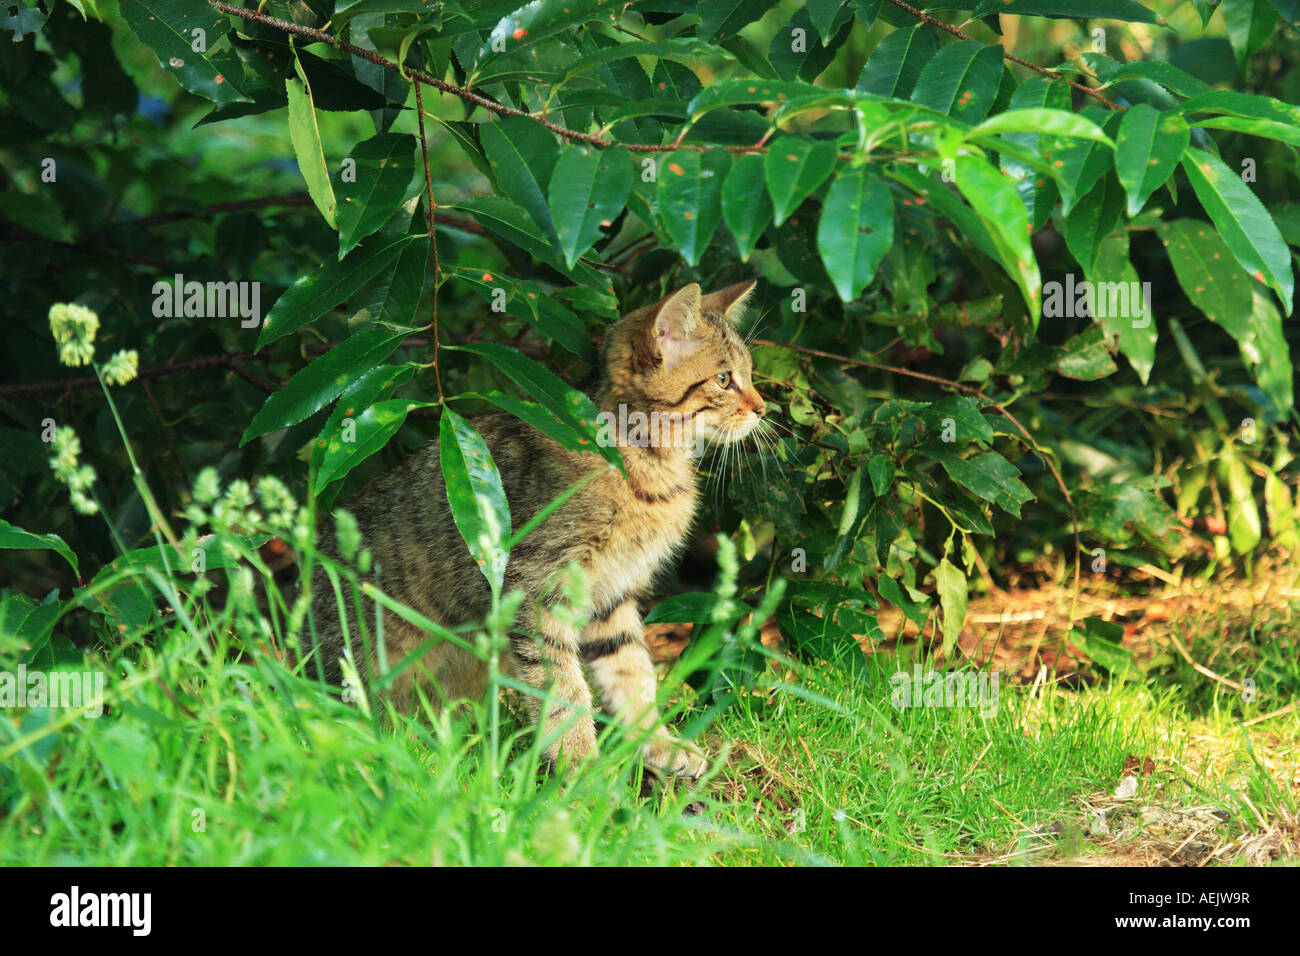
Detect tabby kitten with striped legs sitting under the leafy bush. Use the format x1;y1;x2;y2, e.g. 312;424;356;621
312;282;764;777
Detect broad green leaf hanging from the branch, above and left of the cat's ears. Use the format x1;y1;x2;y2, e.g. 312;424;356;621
550;146;632;269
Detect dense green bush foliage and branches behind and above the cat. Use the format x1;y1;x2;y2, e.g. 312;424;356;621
0;0;1300;676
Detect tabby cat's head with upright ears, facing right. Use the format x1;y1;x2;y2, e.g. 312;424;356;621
605;282;766;444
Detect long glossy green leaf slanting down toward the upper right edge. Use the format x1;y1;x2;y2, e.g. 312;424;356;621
1183;151;1295;315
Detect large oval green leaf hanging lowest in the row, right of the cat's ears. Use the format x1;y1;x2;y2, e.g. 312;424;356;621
816;166;893;302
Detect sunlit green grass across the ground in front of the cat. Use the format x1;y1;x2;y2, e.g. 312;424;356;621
0;587;1300;866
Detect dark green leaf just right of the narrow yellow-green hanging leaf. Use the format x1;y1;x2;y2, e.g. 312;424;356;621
334;133;416;259
